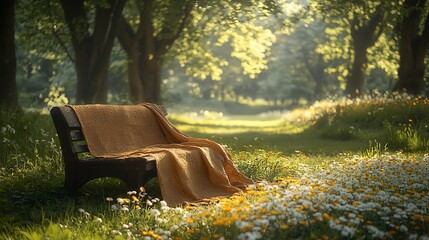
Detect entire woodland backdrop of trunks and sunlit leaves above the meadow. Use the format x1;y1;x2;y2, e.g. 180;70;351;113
0;0;429;108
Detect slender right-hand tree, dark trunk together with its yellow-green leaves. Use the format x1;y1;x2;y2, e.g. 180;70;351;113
313;0;400;98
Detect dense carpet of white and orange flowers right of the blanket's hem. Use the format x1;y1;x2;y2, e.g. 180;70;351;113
176;155;429;239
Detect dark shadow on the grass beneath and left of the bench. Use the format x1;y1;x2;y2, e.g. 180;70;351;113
0;172;160;235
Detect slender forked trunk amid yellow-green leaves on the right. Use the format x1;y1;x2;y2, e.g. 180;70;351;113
345;10;383;98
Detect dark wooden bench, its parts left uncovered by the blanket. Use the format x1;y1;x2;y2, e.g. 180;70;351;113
50;106;157;193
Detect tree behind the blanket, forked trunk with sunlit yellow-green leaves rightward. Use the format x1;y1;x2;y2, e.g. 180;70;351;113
118;0;273;103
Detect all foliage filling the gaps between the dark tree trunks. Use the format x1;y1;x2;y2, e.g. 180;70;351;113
12;0;428;107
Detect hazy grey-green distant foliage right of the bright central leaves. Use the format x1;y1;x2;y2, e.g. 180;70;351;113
258;22;336;104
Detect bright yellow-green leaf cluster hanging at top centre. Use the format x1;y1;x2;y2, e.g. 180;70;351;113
172;1;275;80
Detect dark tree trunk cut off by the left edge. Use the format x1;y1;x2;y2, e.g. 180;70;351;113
0;0;18;107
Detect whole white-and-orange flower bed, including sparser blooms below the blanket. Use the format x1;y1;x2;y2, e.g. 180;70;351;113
75;153;429;239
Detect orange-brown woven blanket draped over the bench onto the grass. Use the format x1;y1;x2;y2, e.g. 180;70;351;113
70;104;252;206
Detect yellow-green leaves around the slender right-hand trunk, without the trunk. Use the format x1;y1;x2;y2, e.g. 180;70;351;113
311;0;402;89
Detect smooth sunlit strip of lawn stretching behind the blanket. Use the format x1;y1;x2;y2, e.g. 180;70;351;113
169;111;369;156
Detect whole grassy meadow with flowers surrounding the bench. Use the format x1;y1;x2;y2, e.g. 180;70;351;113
0;95;429;239
